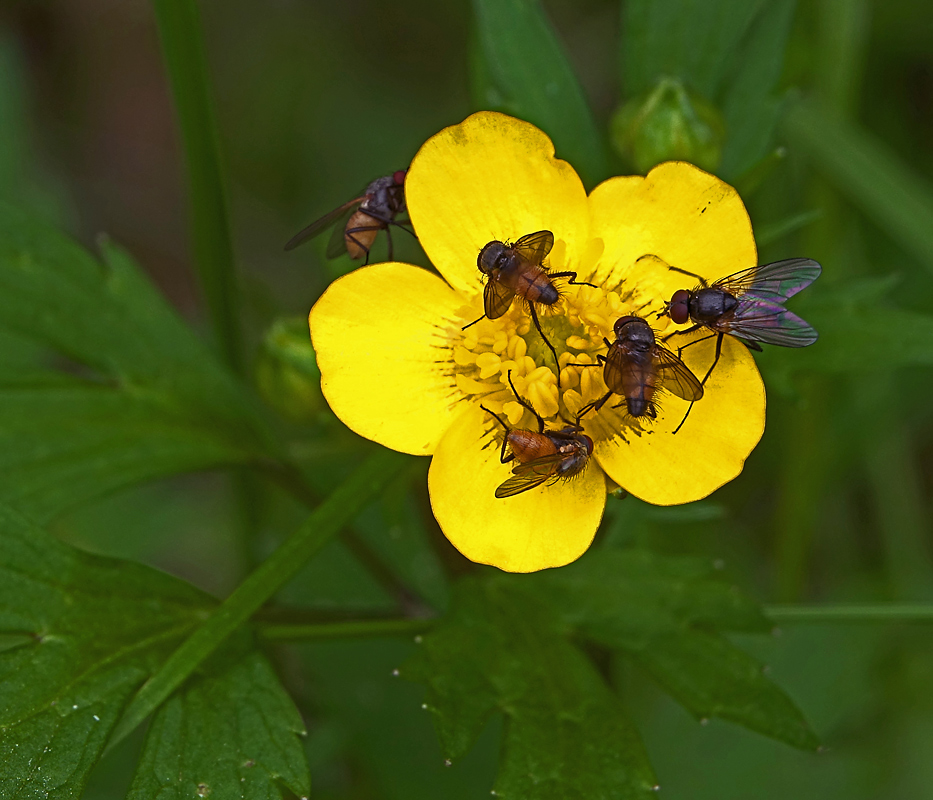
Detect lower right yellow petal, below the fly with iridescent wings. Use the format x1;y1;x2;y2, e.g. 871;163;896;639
594;334;765;506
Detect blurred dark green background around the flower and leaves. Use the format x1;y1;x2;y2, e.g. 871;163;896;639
0;0;933;800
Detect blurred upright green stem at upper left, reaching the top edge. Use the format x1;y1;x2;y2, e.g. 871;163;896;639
153;0;243;372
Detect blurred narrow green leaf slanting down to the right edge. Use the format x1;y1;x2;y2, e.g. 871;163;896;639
783;103;933;270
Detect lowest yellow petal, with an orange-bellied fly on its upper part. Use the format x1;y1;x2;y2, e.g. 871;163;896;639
428;404;606;572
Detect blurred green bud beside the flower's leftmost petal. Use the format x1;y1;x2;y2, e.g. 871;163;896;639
256;317;324;423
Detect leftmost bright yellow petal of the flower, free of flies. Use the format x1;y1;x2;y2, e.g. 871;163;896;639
308;263;463;455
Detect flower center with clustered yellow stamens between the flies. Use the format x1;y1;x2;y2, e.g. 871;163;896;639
449;270;666;440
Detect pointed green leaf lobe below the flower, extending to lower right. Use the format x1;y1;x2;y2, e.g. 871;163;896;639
533;550;819;749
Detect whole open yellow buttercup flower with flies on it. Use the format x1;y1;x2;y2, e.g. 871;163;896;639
310;112;765;572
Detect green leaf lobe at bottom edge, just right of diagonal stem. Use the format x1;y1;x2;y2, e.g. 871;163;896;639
128;648;311;800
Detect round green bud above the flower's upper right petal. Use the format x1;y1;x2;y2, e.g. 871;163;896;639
611;78;725;174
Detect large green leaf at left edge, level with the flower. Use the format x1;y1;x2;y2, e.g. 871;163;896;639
0;207;271;520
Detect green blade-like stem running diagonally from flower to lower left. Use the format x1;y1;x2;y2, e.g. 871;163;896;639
108;450;399;749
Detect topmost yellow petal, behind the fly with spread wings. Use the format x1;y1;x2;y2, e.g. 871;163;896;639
405;111;589;295
